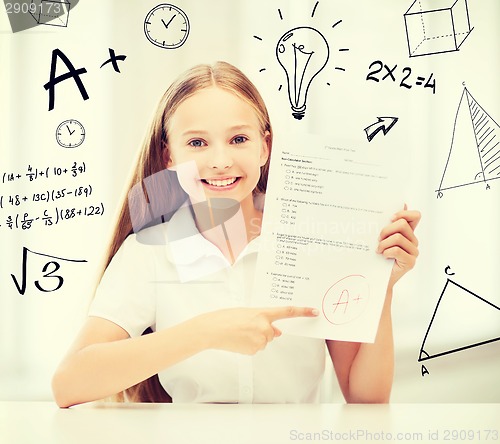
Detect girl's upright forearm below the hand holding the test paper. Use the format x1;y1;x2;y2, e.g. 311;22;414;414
346;287;394;403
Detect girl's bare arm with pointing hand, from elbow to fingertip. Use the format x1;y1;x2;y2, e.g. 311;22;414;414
52;307;317;407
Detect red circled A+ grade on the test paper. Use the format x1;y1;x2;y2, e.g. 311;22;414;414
322;274;370;325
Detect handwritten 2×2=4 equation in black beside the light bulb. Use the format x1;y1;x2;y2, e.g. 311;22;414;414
366;60;436;94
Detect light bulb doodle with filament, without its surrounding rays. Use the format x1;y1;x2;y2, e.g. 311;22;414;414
276;26;330;120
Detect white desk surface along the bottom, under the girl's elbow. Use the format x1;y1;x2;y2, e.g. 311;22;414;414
0;402;500;444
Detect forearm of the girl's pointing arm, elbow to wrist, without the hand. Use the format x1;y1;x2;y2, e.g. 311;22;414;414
52;321;204;407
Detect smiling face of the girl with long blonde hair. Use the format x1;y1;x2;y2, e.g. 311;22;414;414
165;86;270;208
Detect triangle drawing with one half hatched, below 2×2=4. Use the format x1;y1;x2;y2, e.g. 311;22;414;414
436;88;500;197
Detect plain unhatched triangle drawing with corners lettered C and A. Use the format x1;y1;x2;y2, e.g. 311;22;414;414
418;279;500;362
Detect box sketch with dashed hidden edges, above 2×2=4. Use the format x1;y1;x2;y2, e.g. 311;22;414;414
404;0;473;57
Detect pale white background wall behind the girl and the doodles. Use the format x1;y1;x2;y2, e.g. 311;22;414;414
0;0;500;402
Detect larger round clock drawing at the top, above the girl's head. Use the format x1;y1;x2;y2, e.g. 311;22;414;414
144;3;189;49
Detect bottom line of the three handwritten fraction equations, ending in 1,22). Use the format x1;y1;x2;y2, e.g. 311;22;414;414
0;202;104;230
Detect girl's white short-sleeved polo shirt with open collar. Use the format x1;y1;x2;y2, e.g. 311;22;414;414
89;200;325;403
